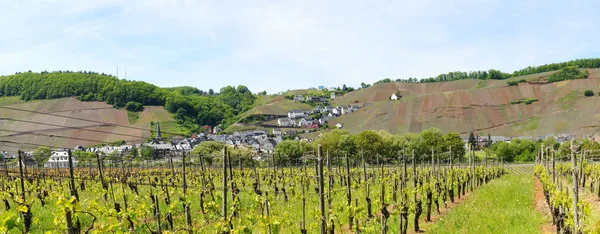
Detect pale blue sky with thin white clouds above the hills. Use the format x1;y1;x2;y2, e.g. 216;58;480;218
0;0;600;93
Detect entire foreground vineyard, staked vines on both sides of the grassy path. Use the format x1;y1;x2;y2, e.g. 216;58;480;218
0;140;600;233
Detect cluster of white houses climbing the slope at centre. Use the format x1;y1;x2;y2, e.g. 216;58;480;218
277;105;364;129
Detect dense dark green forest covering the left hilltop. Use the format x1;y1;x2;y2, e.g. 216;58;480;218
0;71;256;131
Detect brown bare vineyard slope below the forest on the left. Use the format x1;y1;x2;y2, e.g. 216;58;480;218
0;97;177;152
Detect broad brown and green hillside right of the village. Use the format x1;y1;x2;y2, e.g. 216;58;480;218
330;69;600;136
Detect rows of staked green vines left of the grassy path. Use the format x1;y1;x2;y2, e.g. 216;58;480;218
0;147;508;233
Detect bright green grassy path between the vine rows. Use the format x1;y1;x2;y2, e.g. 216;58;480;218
428;172;544;233
